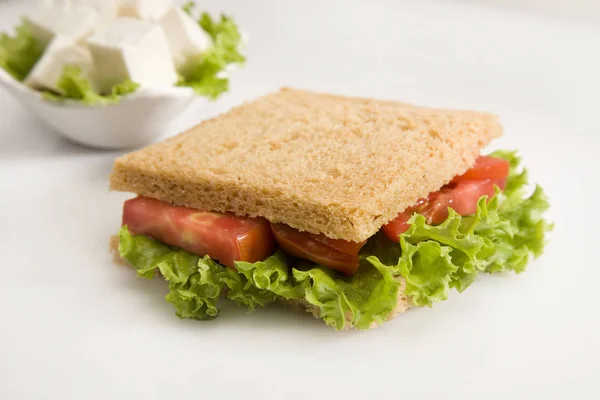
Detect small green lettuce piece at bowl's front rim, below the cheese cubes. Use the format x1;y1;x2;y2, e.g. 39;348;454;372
42;65;139;105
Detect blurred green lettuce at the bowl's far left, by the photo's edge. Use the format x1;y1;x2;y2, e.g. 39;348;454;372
0;21;44;82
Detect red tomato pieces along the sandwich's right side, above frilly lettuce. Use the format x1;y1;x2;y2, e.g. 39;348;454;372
382;180;506;242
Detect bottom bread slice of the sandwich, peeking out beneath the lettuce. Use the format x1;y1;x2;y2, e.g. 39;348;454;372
109;235;414;330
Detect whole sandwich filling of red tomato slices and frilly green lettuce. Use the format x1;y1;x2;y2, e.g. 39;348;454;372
118;152;550;329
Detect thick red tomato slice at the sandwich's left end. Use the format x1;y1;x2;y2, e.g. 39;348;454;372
123;197;275;267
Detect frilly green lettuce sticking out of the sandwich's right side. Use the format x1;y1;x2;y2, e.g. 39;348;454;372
382;152;552;307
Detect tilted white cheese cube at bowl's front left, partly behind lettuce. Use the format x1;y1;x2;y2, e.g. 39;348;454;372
25;35;92;92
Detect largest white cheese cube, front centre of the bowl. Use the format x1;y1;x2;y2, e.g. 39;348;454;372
87;18;177;93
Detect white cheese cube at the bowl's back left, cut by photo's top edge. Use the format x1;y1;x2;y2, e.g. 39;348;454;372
25;0;98;45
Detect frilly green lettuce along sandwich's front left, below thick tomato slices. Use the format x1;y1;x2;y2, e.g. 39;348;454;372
119;226;400;329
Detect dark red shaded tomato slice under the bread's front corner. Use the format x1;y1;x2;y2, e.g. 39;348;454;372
271;224;359;275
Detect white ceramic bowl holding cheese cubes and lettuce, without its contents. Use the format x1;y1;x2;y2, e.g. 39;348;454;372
0;68;204;149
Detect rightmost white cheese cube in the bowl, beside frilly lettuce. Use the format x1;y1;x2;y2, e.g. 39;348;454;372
159;7;212;68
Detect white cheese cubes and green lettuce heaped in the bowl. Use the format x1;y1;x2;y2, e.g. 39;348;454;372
0;0;245;105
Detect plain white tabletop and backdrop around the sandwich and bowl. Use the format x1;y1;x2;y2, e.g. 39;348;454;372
0;0;600;400
